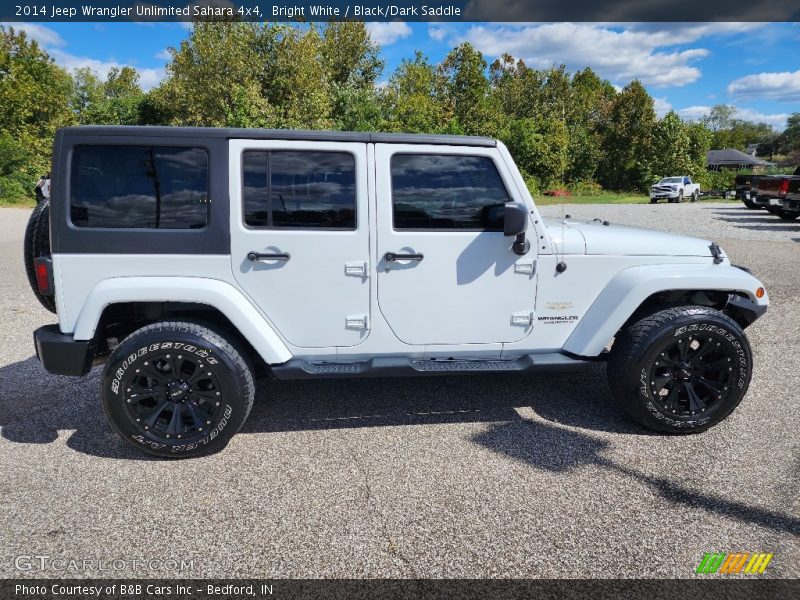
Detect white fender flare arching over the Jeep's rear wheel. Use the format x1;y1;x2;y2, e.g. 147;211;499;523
73;277;292;364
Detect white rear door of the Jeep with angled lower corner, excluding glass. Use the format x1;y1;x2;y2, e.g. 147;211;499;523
230;140;370;348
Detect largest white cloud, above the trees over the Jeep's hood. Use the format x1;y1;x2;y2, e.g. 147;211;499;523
459;23;724;87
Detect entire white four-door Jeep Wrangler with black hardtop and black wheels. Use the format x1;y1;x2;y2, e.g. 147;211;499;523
26;127;768;456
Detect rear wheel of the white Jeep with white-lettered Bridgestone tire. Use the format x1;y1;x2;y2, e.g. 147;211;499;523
102;321;255;458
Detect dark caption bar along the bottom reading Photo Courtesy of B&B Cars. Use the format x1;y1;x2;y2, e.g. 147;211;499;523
0;575;800;600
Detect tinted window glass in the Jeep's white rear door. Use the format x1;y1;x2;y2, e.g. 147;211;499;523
242;150;356;229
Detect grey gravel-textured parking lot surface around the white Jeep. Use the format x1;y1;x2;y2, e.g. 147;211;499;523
0;202;800;578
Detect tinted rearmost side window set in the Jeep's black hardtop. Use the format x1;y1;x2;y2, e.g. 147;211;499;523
70;146;210;229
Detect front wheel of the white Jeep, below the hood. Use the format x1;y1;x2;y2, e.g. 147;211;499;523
608;306;753;434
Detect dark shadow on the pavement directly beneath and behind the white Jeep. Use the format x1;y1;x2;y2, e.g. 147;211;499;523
0;357;636;460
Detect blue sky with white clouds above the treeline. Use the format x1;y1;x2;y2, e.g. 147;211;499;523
6;22;800;129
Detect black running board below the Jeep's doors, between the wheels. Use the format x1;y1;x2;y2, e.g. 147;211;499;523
271;352;596;379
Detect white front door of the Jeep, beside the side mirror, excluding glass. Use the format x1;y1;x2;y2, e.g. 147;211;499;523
375;144;537;345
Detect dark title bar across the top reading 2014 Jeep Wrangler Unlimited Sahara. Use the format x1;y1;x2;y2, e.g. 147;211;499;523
0;0;800;23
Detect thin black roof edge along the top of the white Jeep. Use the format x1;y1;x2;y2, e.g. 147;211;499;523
59;125;497;147
